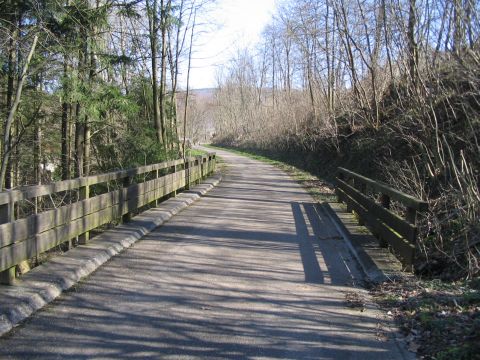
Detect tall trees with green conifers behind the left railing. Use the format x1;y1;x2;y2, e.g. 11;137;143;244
0;0;204;189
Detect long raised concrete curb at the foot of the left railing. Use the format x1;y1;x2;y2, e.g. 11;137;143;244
0;174;222;336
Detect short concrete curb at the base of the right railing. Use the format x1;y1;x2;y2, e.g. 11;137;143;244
320;203;405;283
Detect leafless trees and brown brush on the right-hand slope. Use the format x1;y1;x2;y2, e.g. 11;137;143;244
213;0;480;278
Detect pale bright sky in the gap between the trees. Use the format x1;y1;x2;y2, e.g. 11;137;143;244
188;0;275;89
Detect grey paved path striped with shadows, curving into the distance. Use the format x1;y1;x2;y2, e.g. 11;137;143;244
0;148;408;359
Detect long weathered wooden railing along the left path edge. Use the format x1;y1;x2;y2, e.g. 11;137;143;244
0;153;216;284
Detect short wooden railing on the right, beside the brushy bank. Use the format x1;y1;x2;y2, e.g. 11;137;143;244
336;168;428;270
